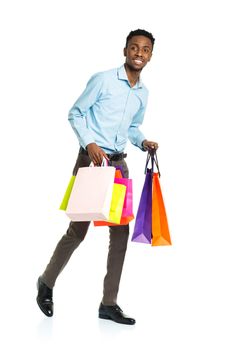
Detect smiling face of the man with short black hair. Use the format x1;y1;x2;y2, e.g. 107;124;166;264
124;35;153;71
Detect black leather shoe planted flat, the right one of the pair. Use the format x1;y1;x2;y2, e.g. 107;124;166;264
99;303;136;325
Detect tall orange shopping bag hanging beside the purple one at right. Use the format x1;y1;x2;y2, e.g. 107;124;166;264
152;173;171;246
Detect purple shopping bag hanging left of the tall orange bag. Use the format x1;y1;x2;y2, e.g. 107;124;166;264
132;169;152;244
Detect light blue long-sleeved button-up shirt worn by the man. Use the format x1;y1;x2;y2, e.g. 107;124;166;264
68;65;148;153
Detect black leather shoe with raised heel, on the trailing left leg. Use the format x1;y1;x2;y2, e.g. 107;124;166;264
36;277;53;317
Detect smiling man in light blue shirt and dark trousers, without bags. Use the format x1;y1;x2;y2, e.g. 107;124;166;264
37;29;158;325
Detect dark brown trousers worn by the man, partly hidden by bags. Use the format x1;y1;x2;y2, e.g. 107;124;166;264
42;153;129;305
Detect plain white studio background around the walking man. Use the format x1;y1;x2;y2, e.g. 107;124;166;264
0;0;226;350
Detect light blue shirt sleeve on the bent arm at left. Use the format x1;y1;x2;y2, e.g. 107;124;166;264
68;73;103;148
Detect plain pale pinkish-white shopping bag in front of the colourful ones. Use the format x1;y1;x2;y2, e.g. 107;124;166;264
66;166;115;221
